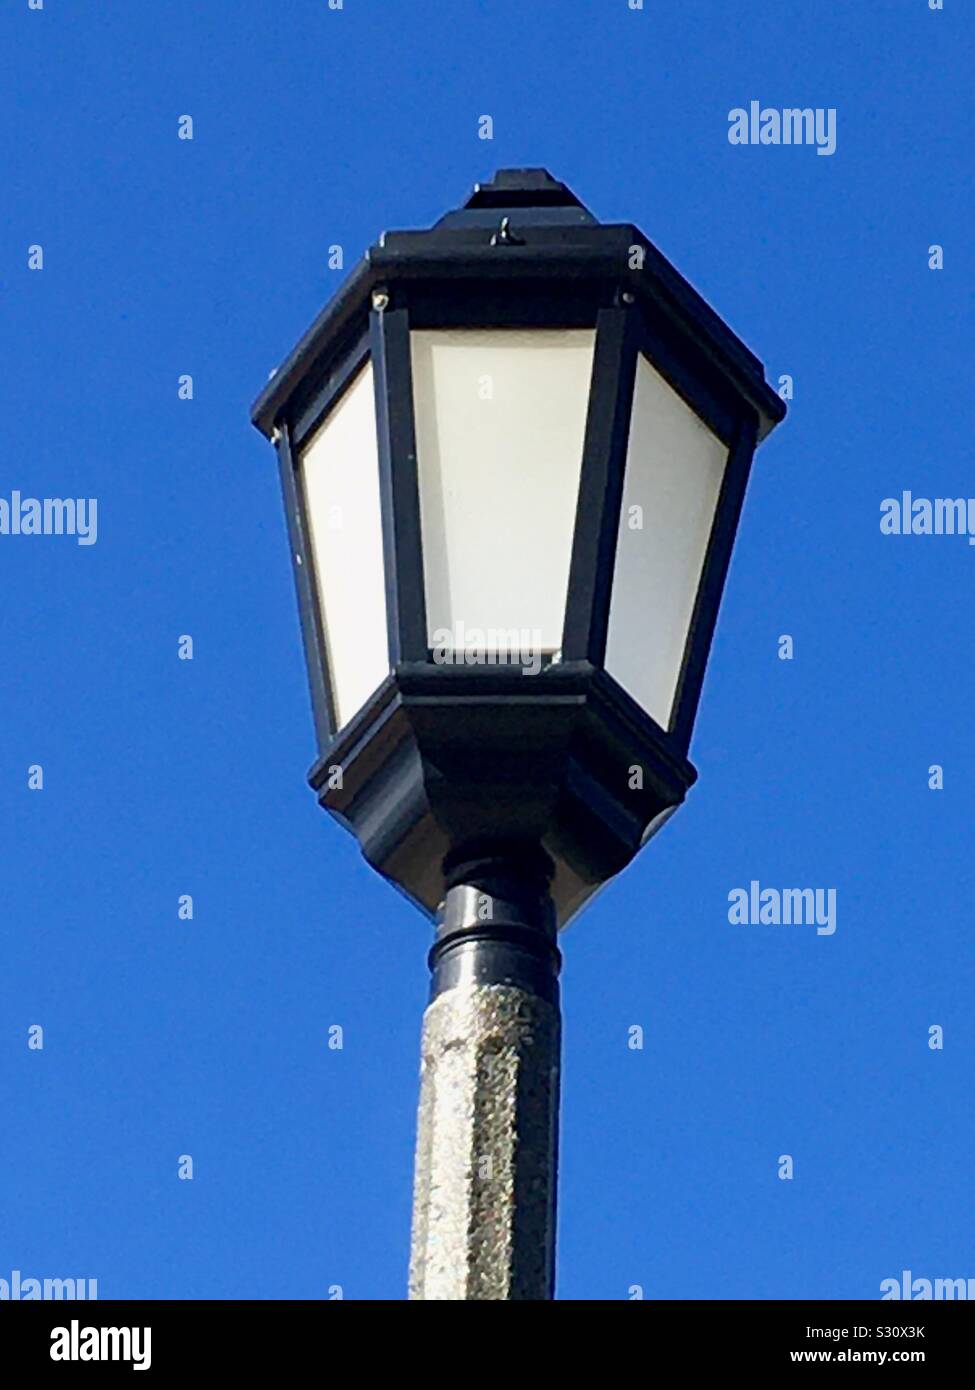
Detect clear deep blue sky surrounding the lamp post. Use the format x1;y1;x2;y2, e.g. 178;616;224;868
0;0;975;1298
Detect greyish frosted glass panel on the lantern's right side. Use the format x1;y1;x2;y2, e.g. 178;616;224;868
606;357;727;728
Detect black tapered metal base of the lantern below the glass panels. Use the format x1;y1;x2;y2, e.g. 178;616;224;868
310;662;697;924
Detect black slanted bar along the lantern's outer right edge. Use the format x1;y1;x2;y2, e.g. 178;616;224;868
670;411;758;751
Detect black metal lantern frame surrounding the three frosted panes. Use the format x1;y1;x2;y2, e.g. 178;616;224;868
253;170;784;923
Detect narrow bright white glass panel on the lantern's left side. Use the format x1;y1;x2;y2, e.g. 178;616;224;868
300;363;389;728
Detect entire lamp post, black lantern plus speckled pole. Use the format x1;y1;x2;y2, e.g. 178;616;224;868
253;170;784;1300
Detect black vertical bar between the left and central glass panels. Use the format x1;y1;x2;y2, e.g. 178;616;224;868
370;309;427;669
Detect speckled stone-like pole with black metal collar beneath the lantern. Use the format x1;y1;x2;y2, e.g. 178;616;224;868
409;850;561;1300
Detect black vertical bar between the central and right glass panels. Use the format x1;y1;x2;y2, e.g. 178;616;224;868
562;307;637;666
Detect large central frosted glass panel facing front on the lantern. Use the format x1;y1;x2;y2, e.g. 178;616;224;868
412;328;595;660
